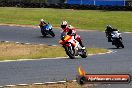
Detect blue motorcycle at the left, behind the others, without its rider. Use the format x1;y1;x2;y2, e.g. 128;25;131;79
41;23;55;37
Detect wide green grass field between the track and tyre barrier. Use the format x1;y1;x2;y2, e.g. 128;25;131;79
0;7;132;32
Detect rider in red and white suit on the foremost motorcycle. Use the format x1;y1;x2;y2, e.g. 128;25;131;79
61;21;85;49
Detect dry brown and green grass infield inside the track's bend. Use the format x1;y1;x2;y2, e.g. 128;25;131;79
0;42;108;60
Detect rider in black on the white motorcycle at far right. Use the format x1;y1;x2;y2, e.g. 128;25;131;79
105;25;119;42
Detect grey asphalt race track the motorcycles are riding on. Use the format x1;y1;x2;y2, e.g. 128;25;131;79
0;26;132;88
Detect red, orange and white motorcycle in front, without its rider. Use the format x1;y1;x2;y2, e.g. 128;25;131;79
59;35;87;59
